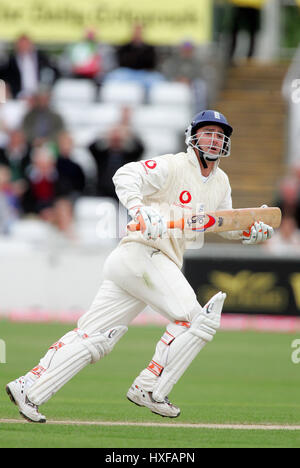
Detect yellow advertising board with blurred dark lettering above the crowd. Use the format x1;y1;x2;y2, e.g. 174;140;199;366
0;0;212;44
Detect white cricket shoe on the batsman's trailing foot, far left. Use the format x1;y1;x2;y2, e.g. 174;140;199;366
6;377;46;423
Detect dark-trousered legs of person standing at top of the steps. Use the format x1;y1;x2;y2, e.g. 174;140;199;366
229;0;265;62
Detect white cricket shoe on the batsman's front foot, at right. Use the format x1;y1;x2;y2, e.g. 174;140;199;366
127;384;180;418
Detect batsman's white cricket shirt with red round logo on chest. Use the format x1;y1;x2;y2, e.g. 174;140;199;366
113;147;241;268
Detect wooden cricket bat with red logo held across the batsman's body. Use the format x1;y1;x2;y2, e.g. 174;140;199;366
127;207;281;232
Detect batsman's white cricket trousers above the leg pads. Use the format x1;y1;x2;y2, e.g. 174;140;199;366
78;242;199;334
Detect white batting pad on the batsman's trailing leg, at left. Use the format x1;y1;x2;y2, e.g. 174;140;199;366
27;326;127;406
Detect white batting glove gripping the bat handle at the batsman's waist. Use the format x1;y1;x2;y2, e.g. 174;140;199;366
129;206;167;240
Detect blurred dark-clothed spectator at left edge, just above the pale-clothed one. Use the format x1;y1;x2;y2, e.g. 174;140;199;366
0;130;30;186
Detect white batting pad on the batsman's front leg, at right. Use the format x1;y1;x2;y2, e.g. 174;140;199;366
153;292;226;401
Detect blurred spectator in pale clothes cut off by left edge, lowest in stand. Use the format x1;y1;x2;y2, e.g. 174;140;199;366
0;164;20;234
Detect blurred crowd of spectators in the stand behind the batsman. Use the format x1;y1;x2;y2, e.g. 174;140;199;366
0;24;216;239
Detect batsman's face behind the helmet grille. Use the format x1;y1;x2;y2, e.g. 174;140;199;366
196;125;227;156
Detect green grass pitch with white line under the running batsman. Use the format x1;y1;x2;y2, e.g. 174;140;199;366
0;321;300;448
